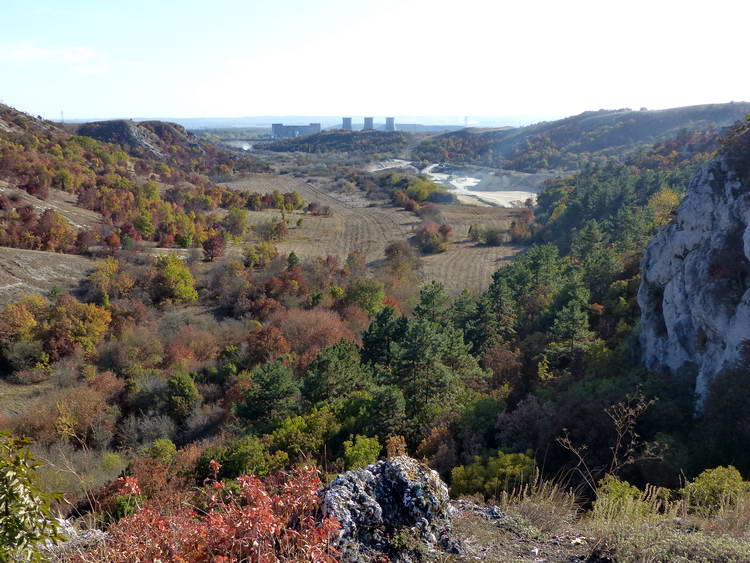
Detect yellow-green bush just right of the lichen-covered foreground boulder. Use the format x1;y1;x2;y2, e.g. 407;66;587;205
451;451;536;499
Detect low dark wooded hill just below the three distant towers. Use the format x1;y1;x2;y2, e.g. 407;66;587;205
263;130;412;156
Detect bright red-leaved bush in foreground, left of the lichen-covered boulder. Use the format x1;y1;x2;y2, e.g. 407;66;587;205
81;467;340;563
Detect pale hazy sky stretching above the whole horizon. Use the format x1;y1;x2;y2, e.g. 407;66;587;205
0;0;750;118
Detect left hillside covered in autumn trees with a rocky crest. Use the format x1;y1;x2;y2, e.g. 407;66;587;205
0;106;303;254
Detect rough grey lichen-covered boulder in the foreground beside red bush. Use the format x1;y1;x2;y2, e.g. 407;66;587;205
322;456;460;562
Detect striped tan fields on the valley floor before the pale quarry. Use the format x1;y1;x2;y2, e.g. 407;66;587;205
225;174;520;292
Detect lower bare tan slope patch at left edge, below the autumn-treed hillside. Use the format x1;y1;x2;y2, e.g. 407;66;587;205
0;247;94;303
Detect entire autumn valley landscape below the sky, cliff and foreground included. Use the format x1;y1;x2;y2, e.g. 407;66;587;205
0;99;750;563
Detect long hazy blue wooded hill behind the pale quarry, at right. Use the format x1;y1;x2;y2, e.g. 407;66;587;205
414;102;750;172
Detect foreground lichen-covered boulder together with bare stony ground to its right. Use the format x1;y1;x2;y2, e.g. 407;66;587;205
322;456;607;563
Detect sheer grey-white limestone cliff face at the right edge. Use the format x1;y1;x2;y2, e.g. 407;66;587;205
638;130;750;400
